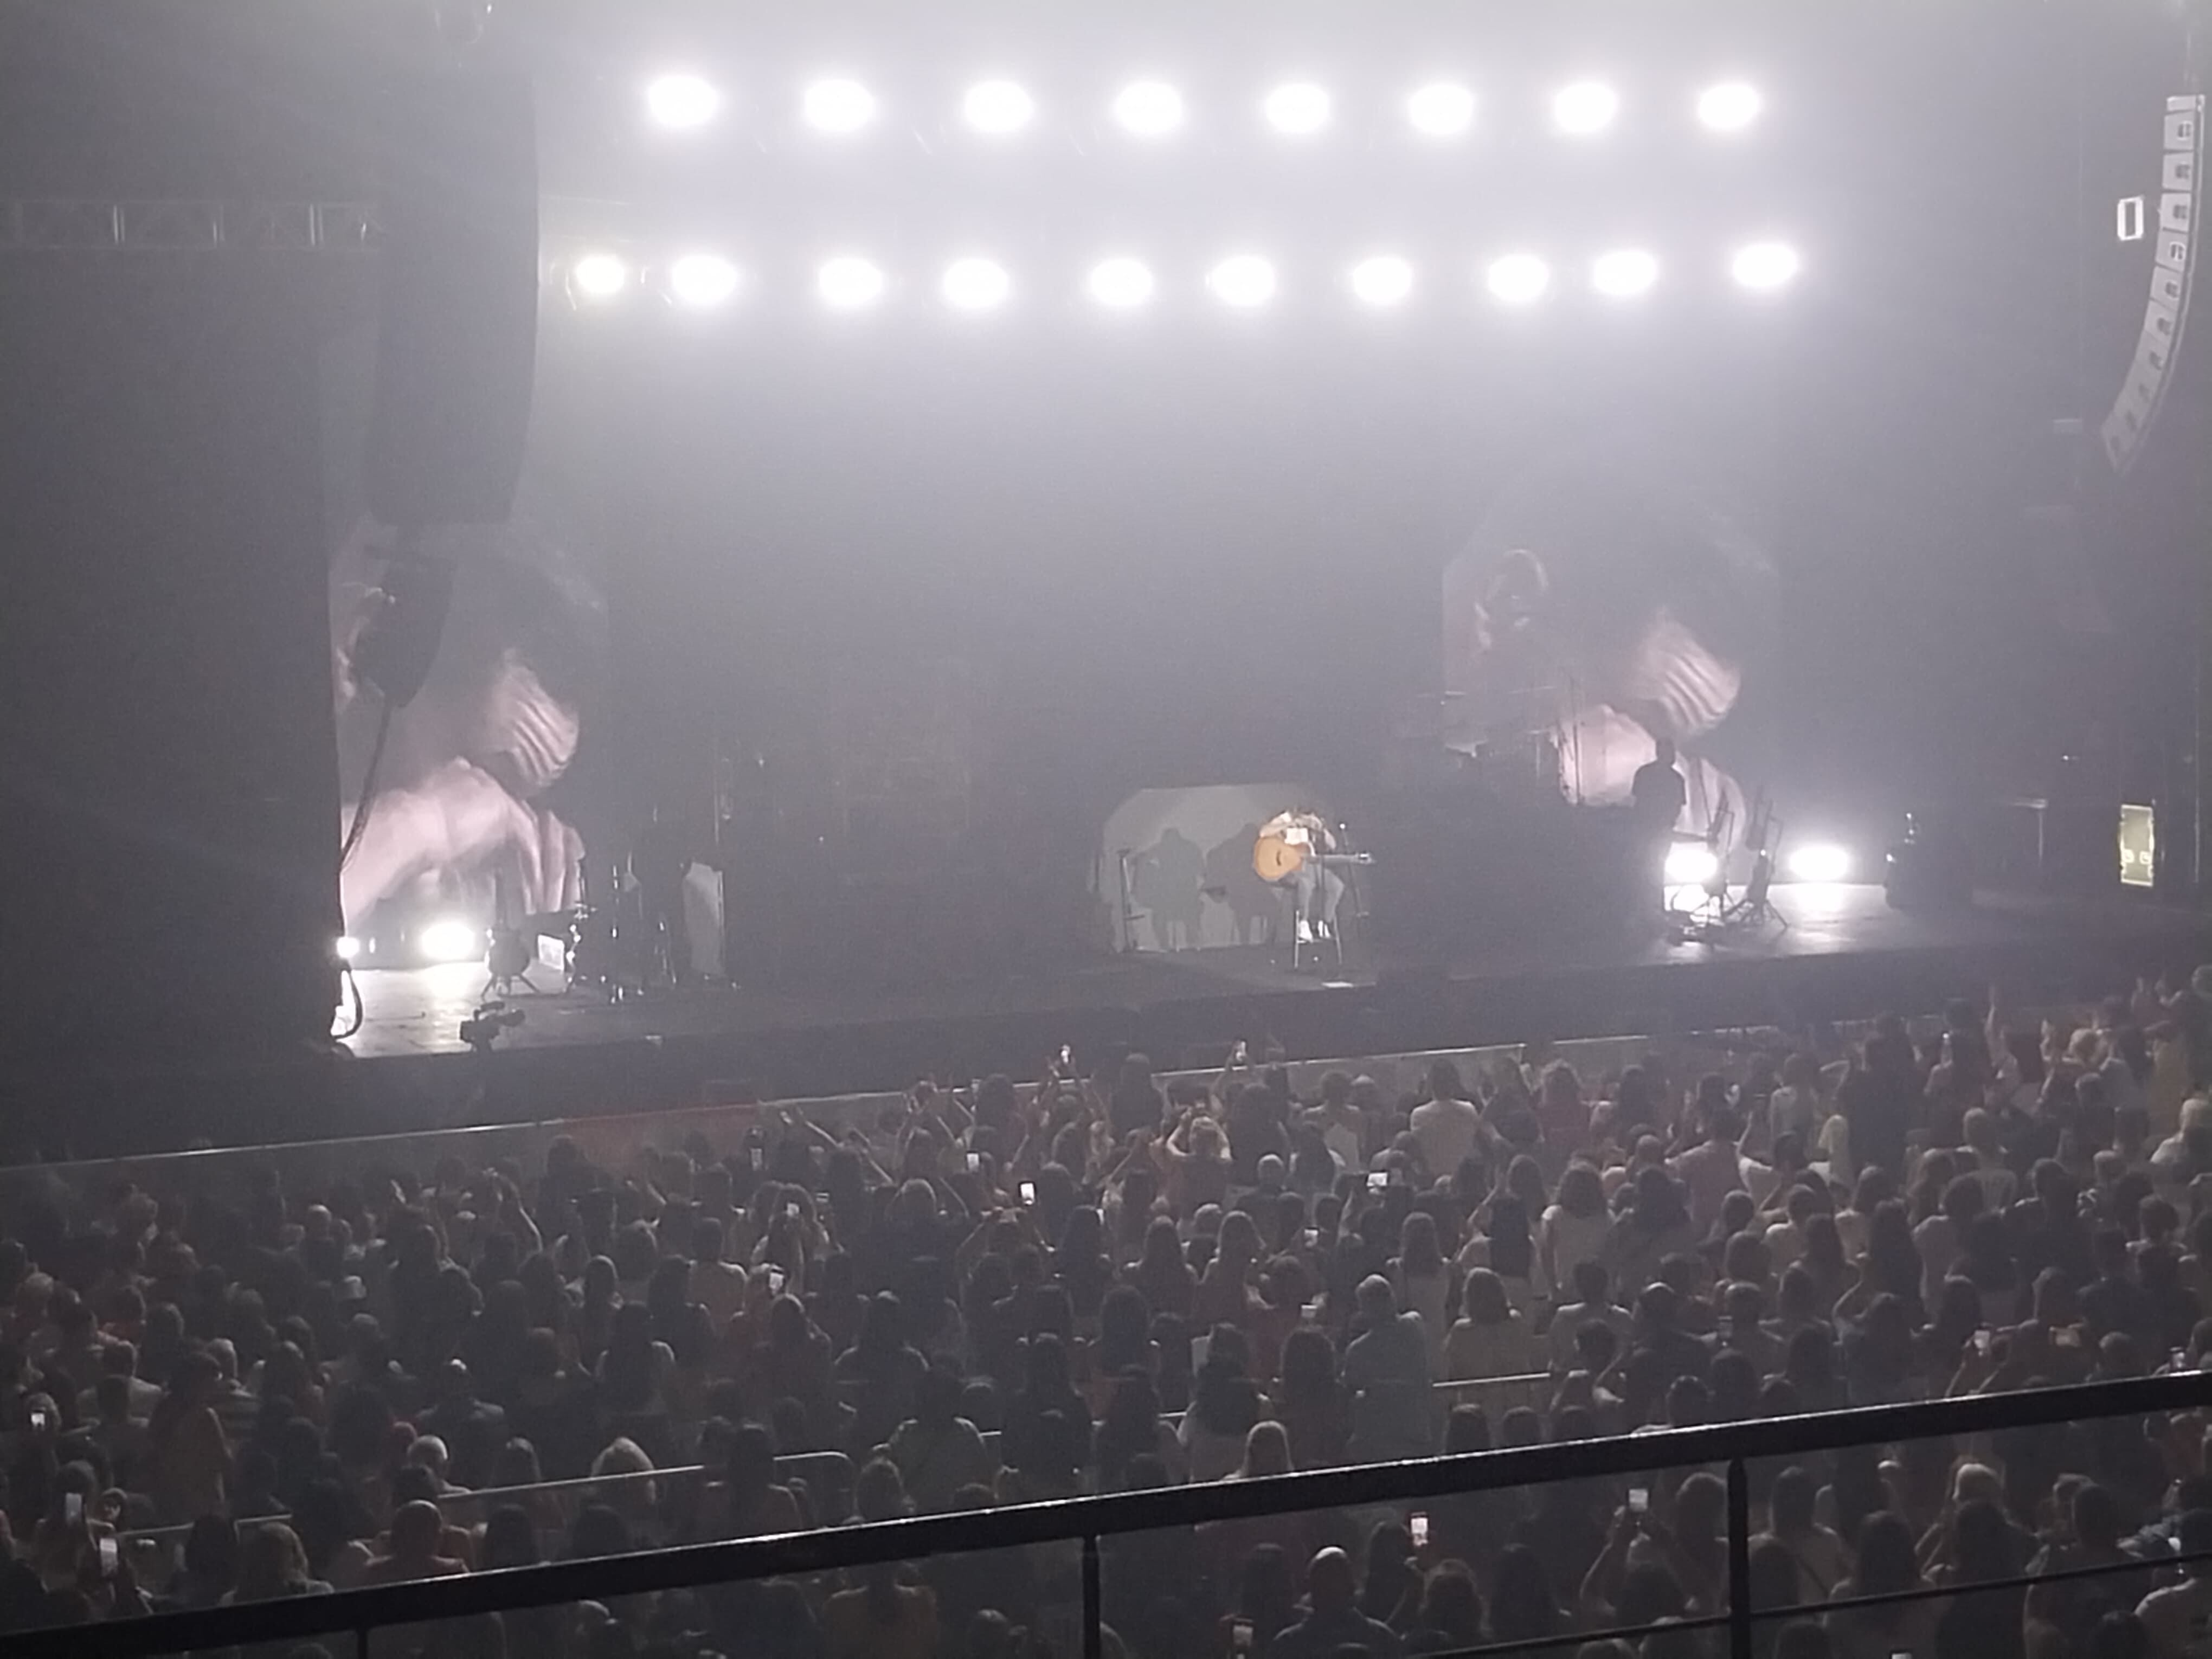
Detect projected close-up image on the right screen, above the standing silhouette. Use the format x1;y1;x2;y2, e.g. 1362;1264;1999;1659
1444;455;1774;829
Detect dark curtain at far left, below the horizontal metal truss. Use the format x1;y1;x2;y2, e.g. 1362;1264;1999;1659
0;254;338;1062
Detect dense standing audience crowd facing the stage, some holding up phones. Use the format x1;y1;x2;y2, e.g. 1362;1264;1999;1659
0;971;2212;1659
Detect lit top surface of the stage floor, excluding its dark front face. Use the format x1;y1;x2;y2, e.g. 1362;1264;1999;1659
345;885;2203;1059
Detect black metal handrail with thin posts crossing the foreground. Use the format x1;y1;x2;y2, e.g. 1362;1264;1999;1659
0;1372;2212;1659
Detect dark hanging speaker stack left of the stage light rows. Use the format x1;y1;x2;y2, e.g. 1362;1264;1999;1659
367;73;537;529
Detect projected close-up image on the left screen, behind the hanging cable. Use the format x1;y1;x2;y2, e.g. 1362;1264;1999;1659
330;526;602;927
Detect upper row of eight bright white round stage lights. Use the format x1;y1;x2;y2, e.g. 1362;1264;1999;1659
646;73;1763;142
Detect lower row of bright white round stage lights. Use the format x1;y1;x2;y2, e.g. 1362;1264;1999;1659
562;241;1801;312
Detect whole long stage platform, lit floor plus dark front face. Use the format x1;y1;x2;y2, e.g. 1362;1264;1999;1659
307;885;2212;1128
